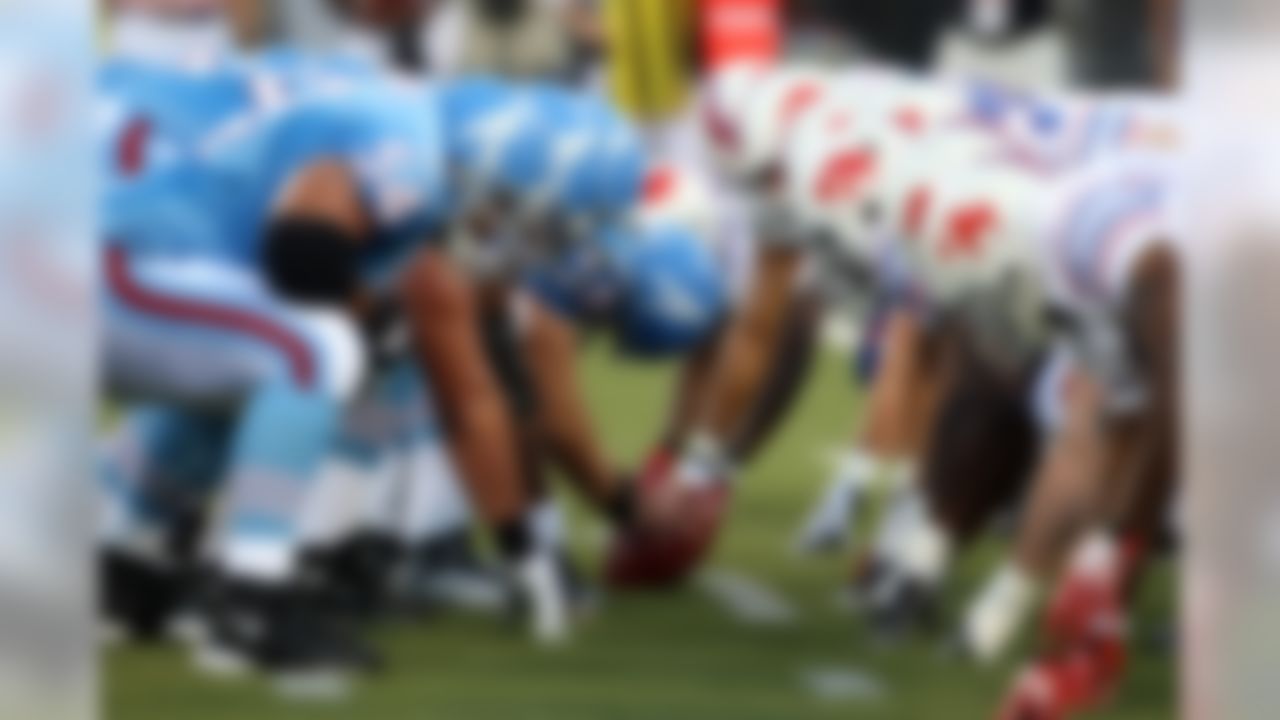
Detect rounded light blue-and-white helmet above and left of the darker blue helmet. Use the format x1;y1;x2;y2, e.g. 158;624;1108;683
442;78;646;280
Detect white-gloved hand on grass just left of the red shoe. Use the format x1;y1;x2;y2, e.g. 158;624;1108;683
963;561;1041;662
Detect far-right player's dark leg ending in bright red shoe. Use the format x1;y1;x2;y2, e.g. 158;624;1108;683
1007;246;1181;714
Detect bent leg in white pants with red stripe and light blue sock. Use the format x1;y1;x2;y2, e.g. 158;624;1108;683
105;254;367;671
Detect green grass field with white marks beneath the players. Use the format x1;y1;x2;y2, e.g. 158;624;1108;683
104;348;1175;720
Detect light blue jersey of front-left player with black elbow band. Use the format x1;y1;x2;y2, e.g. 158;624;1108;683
104;78;445;273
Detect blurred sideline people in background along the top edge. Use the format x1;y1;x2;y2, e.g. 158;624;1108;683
217;0;1176;99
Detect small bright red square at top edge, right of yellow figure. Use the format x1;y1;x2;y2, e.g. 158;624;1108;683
698;0;783;72
